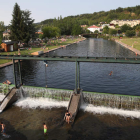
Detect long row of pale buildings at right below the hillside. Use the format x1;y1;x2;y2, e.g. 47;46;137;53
110;19;140;27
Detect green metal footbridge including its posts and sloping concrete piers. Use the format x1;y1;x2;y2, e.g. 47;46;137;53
0;55;140;122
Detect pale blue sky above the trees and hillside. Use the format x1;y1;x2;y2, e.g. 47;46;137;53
0;0;140;25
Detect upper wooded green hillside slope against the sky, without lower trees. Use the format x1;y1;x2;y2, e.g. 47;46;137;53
41;5;140;25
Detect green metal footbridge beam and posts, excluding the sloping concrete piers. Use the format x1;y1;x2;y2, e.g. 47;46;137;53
0;55;140;92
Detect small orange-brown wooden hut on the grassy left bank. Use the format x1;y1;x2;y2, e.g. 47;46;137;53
1;40;18;52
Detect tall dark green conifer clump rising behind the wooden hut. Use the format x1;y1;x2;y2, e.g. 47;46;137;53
10;3;35;43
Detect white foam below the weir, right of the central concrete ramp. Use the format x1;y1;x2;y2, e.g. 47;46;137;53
81;104;140;119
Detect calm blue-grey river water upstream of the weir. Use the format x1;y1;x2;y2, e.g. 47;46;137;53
0;39;140;95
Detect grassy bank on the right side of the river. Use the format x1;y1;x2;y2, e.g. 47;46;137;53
112;38;140;56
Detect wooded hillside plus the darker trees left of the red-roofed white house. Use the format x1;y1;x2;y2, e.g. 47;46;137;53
36;5;140;35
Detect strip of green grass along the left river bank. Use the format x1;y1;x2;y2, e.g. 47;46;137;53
0;38;82;64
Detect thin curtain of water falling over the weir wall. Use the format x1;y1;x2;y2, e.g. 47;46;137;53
0;84;140;110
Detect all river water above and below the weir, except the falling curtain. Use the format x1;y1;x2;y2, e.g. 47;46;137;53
0;38;140;140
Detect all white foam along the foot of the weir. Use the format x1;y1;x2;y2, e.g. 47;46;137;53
0;95;140;119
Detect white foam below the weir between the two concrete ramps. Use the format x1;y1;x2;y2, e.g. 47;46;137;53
15;97;68;109
